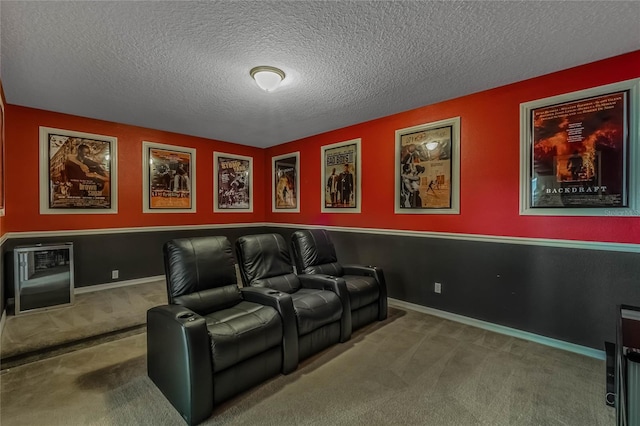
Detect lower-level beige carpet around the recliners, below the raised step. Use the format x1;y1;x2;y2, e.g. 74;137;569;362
0;308;615;426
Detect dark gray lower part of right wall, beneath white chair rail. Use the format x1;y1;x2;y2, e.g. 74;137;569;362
269;228;640;350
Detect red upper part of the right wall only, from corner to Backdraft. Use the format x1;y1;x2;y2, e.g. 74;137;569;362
265;51;640;243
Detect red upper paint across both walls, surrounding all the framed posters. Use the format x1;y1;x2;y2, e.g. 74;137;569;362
5;51;640;243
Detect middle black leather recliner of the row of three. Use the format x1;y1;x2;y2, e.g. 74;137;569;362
236;234;351;360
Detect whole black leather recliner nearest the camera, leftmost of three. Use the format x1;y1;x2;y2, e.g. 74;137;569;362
147;237;298;424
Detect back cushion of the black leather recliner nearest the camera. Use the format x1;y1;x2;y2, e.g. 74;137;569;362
163;237;242;315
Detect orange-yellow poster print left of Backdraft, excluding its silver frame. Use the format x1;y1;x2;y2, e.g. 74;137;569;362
399;126;453;209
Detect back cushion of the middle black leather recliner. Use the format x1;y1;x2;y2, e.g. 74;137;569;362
236;234;300;293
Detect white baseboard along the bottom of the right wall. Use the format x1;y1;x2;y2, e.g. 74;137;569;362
389;298;606;361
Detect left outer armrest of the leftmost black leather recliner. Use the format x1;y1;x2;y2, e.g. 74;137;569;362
147;305;213;424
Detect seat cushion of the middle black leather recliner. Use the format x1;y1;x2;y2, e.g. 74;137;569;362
291;288;342;336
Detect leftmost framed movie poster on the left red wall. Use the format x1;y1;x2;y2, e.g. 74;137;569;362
40;127;118;214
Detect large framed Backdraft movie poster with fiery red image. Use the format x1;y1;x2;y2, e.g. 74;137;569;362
520;80;640;216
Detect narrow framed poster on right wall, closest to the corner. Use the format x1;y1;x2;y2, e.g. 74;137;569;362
271;152;300;213
